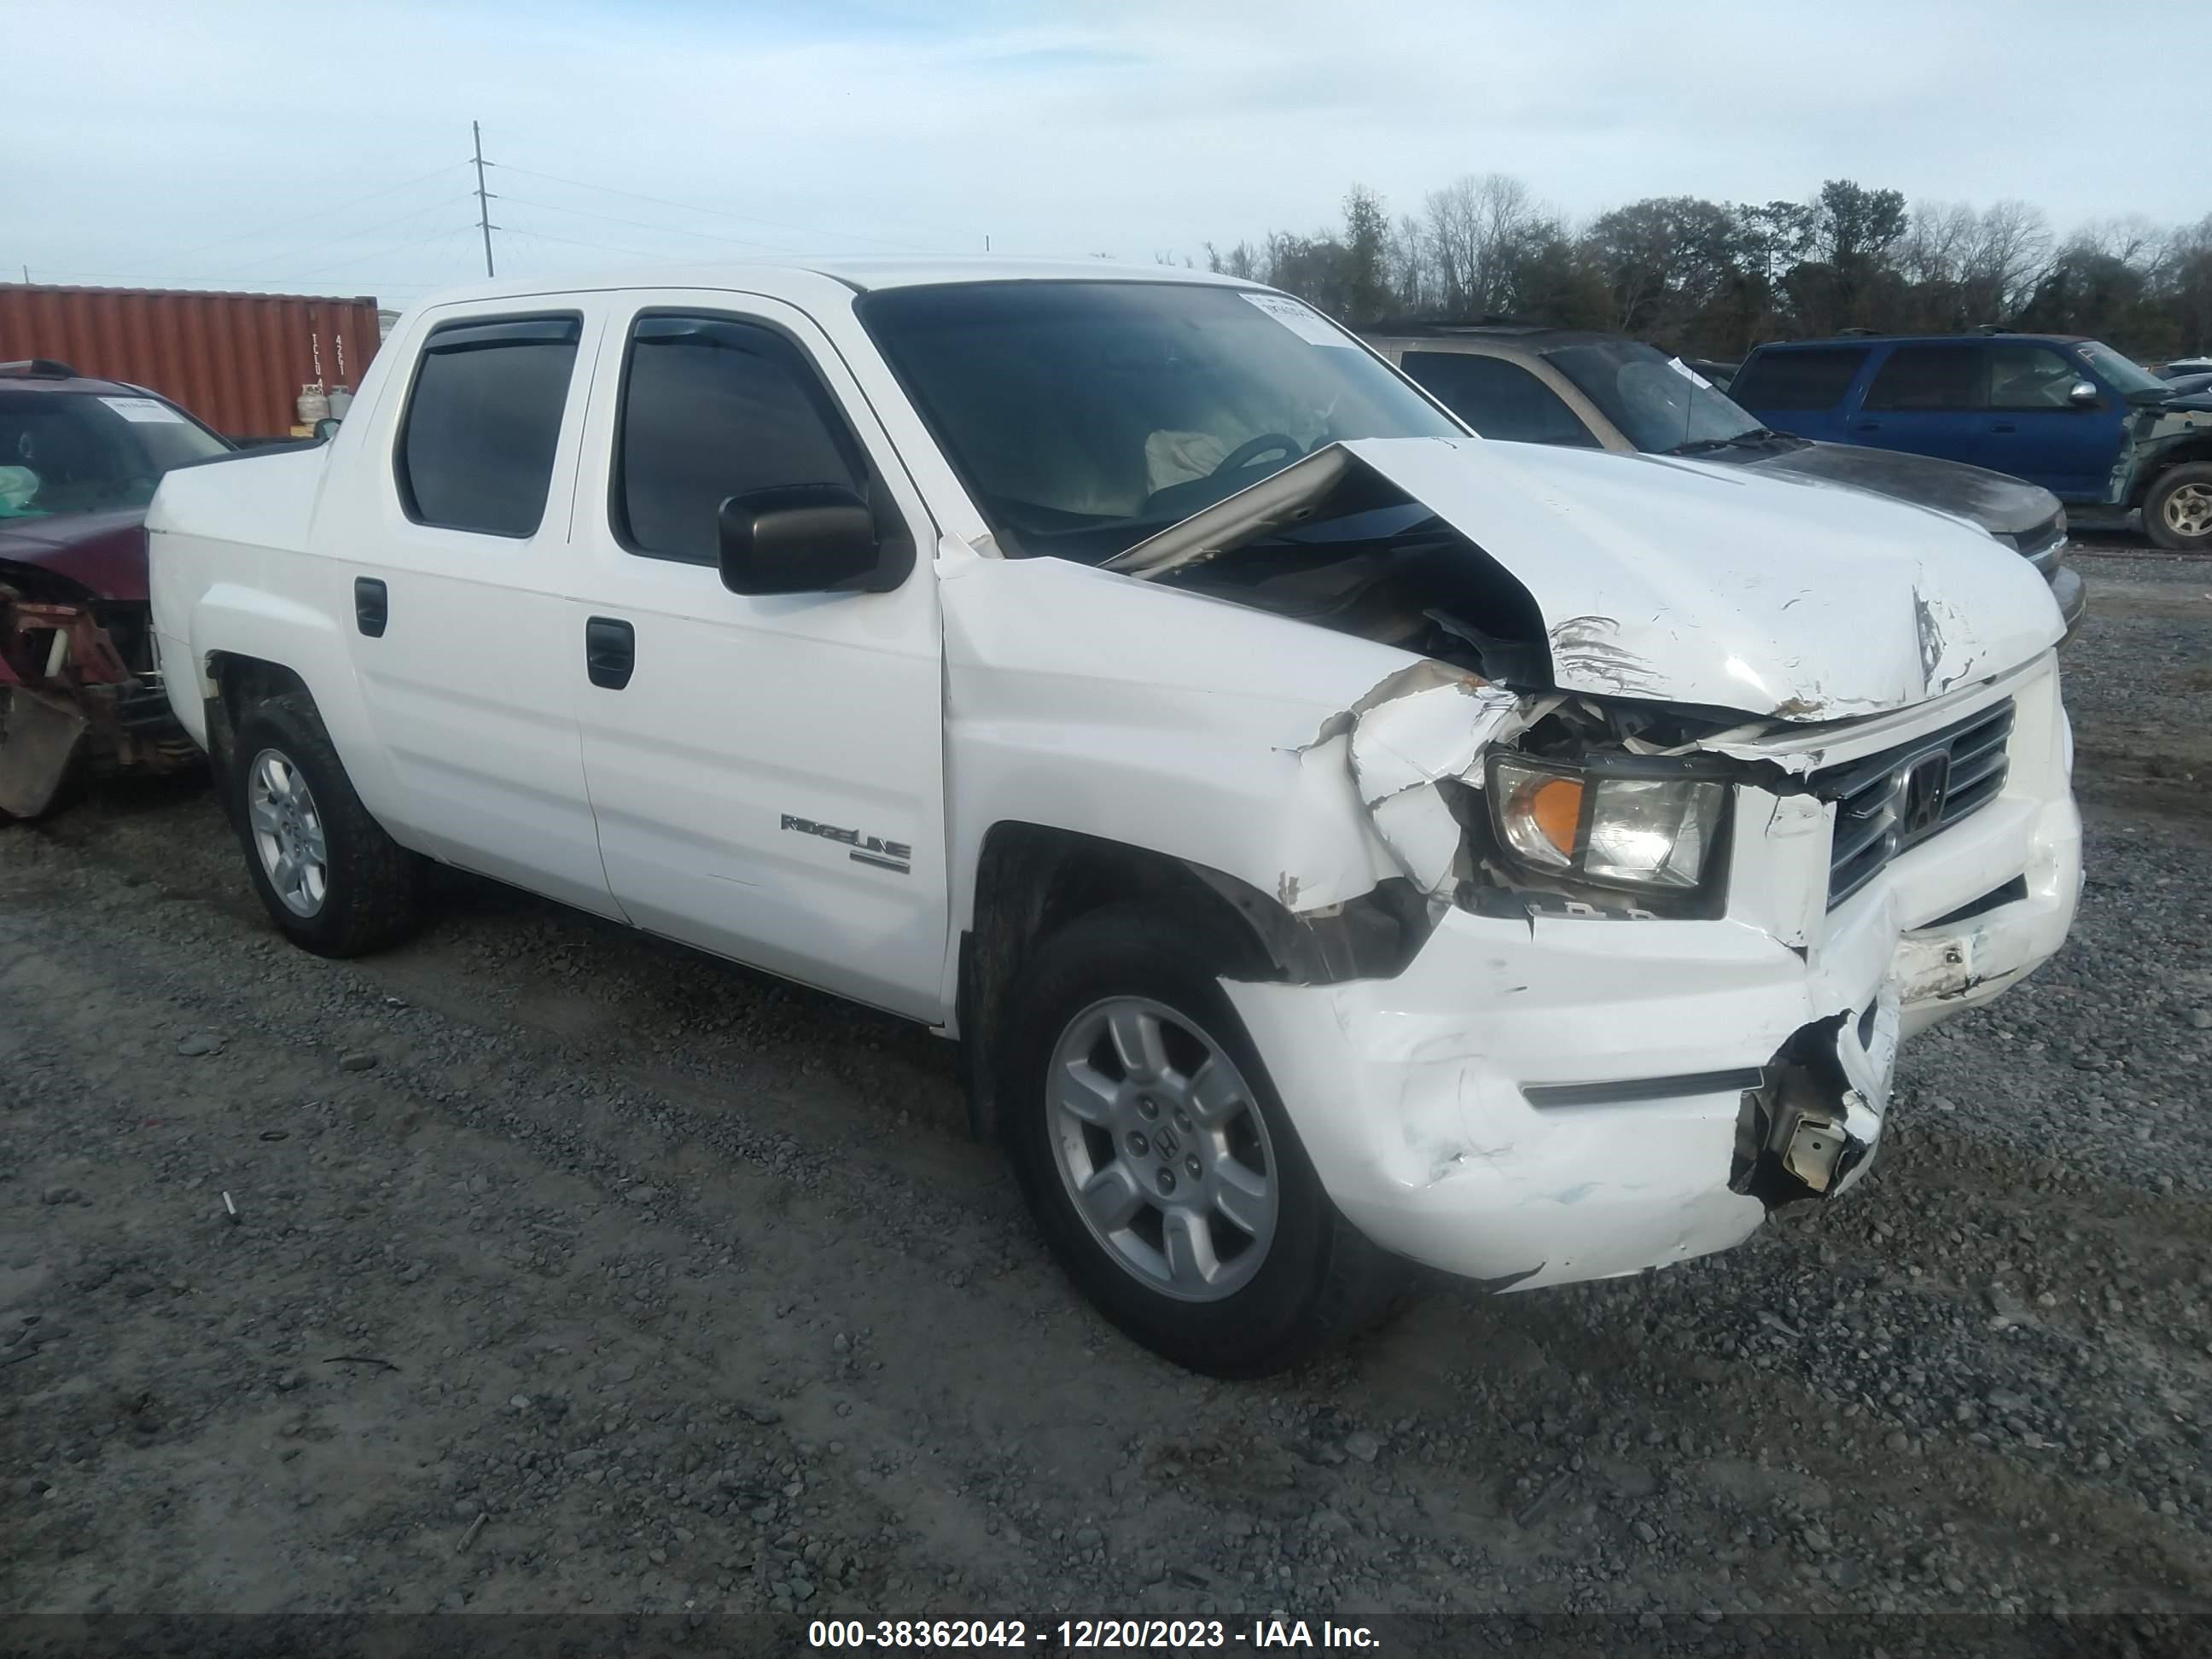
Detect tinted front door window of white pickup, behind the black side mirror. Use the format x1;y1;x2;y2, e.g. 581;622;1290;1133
610;317;867;564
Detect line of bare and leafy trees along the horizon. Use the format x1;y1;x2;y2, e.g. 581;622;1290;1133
1206;172;2212;356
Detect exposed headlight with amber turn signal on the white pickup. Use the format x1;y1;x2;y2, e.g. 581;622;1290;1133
1487;754;1727;894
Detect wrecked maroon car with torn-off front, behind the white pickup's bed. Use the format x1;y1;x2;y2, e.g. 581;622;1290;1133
0;358;232;818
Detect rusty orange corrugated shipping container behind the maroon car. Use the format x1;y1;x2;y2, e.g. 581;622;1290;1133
0;283;378;440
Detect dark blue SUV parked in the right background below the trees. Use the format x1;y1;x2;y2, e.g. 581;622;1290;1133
1727;329;2212;550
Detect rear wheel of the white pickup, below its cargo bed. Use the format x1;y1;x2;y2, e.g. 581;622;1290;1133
224;692;427;956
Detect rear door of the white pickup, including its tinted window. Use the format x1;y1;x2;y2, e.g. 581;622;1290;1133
317;296;613;913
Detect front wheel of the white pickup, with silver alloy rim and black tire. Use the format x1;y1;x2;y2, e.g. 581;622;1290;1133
1000;907;1402;1378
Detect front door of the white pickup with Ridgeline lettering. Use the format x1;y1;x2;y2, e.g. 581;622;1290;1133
568;294;949;1020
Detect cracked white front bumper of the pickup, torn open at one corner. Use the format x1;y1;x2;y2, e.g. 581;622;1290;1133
1225;655;2081;1288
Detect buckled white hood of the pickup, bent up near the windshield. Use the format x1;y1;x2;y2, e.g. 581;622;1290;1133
1106;438;2064;721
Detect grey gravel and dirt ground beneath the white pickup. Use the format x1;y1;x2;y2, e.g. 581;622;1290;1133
0;546;2212;1617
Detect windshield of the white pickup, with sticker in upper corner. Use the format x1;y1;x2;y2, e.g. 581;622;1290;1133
859;281;1466;564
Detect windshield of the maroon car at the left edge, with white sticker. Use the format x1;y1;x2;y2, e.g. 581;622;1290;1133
0;392;230;518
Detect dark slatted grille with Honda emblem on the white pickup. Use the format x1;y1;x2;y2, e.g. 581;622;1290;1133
1812;696;2013;909
